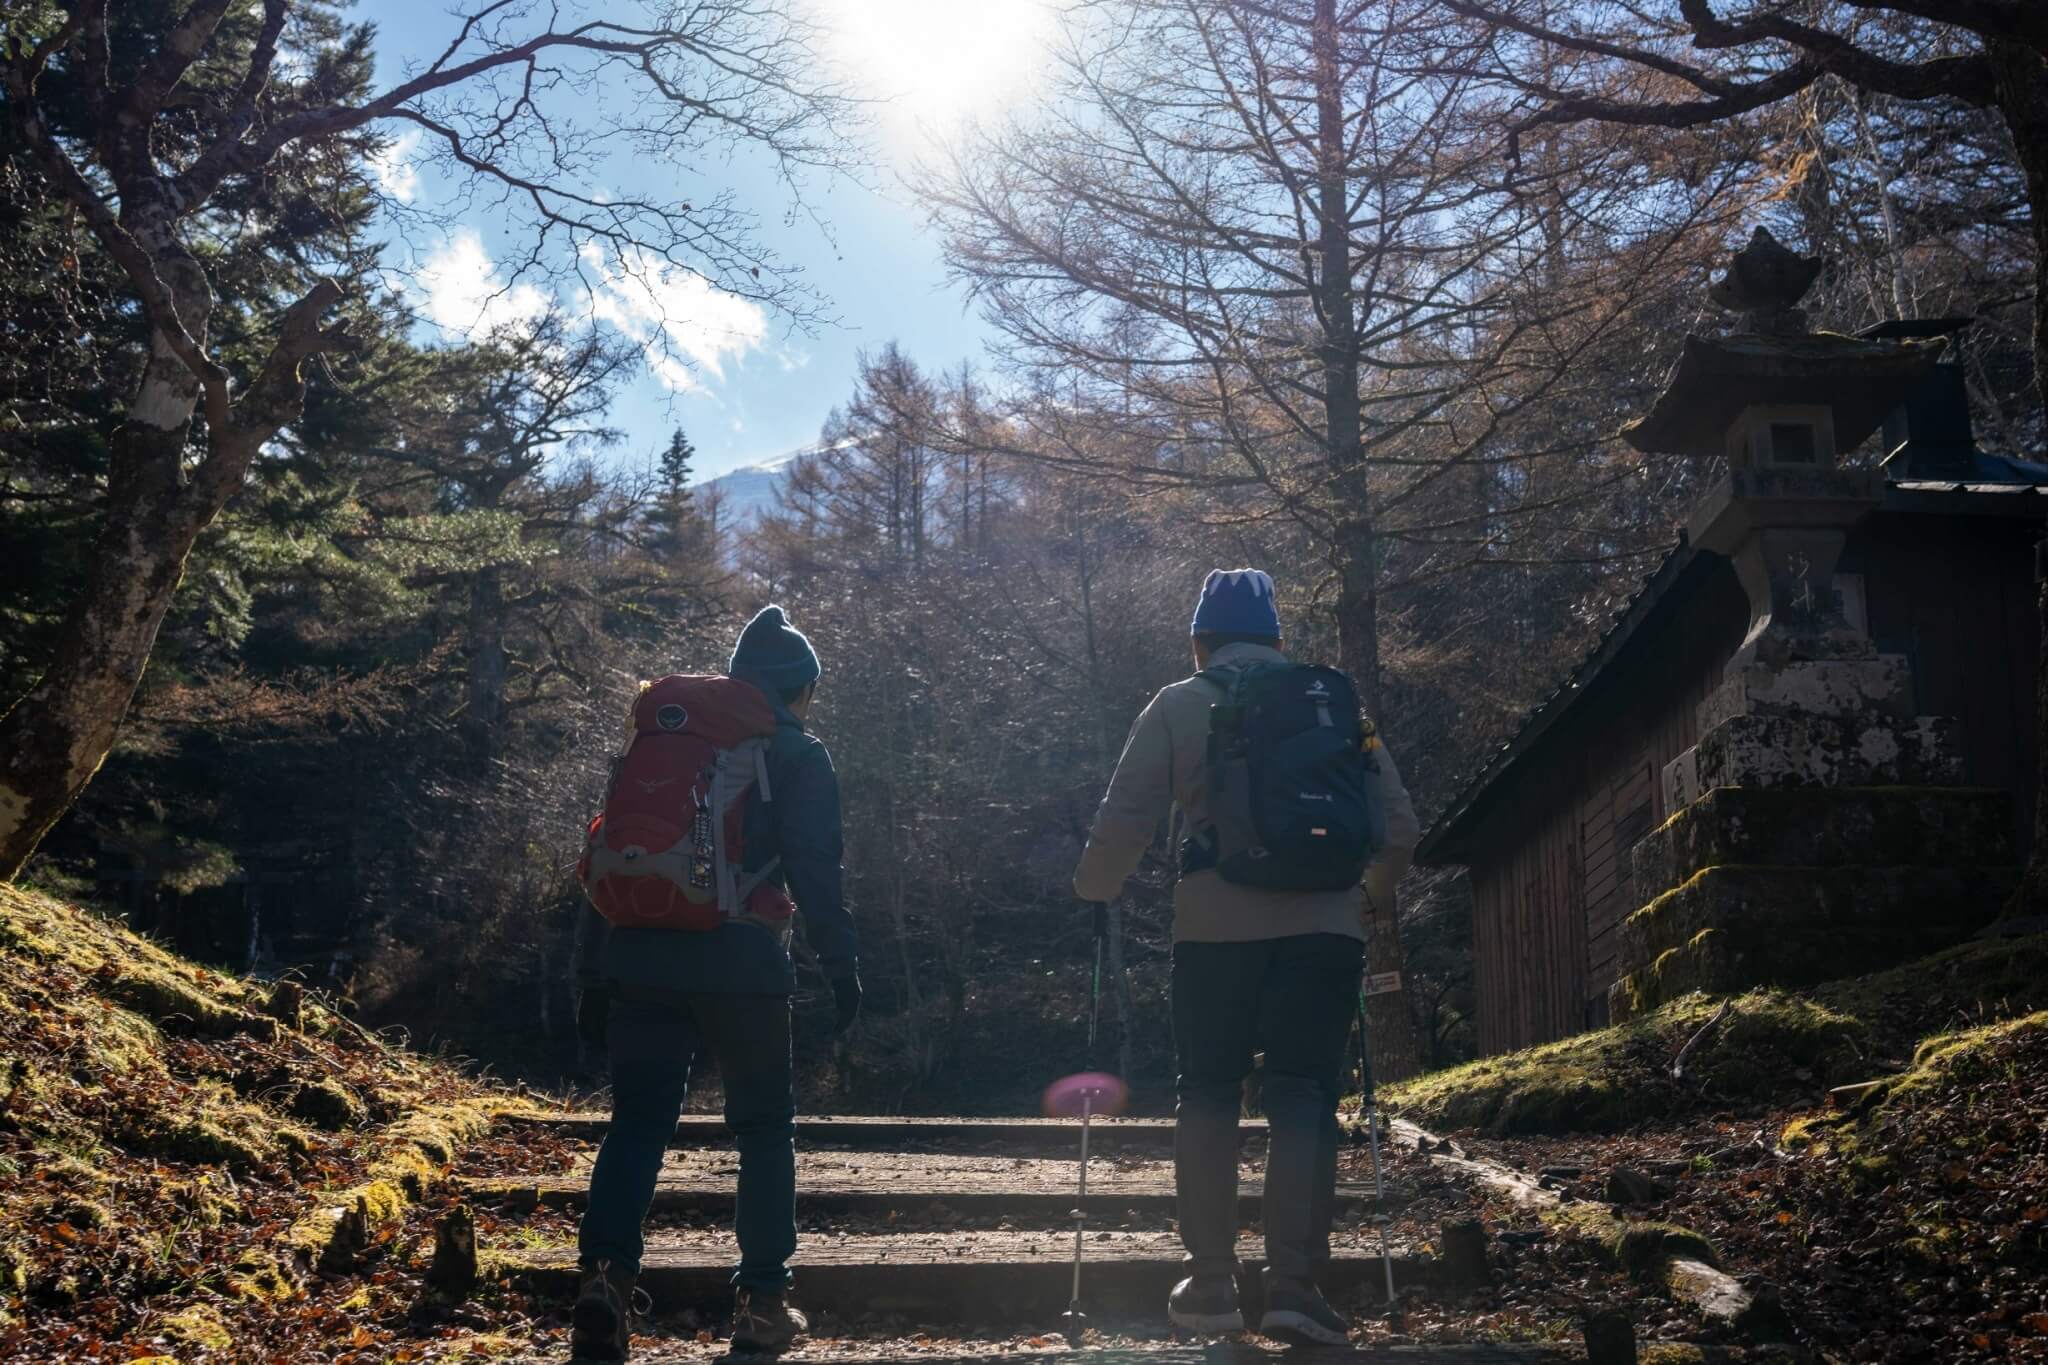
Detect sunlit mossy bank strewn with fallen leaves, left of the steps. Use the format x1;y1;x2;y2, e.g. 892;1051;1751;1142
0;886;548;1361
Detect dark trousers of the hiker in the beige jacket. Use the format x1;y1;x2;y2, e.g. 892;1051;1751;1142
1174;933;1364;1283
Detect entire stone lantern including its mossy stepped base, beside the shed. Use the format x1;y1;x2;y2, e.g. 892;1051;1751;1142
1608;229;2011;1021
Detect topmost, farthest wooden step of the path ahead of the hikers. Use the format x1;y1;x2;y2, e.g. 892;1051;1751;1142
506;1111;1266;1152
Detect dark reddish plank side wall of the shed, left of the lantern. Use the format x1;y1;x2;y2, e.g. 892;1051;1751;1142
1470;557;1749;1054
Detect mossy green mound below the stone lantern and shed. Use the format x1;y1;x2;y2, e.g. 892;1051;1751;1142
1382;935;2048;1134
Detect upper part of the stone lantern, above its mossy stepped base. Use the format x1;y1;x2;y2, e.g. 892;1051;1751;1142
1622;227;1960;810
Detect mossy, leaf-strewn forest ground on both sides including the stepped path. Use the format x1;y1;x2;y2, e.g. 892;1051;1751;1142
0;890;2048;1365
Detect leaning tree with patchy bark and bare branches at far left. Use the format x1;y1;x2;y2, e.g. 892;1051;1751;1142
0;0;860;878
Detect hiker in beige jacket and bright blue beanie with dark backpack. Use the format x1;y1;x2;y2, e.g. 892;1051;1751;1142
1073;569;1421;1345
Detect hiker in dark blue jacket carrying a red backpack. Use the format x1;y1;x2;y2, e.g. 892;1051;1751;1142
569;606;860;1361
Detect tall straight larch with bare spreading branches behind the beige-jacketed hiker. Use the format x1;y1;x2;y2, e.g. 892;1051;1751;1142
924;0;1736;1076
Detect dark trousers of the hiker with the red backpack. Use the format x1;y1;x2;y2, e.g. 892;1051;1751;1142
578;995;797;1291
